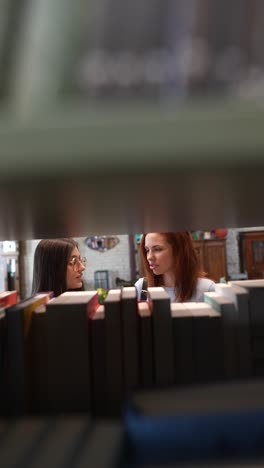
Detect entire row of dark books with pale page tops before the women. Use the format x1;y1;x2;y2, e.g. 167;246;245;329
0;280;264;417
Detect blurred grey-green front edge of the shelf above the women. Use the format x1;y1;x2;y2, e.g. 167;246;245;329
0;99;264;173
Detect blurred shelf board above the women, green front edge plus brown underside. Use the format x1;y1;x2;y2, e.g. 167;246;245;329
0;100;264;240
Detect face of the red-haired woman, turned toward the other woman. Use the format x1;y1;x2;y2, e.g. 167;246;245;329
145;232;175;275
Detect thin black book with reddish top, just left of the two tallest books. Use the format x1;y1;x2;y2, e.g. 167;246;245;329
89;305;108;417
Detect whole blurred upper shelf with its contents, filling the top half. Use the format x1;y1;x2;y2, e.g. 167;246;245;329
0;0;264;240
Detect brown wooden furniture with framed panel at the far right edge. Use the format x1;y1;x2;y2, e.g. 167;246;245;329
239;231;264;279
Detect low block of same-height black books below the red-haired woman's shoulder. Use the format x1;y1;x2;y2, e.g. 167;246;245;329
171;302;224;385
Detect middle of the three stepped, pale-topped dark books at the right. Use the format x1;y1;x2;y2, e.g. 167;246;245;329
215;283;252;378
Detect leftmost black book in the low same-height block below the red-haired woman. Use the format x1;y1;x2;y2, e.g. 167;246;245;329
171;302;194;384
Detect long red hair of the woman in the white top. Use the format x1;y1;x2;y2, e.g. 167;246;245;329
139;231;205;302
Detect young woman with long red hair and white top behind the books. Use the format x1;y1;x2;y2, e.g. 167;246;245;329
135;231;215;302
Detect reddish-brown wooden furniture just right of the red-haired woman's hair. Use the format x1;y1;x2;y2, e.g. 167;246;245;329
193;239;228;283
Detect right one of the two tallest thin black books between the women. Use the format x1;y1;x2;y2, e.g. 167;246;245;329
121;286;139;391
